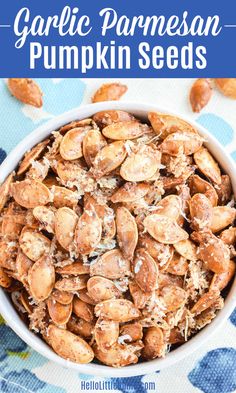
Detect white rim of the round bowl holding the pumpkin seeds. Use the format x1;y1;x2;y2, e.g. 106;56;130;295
0;101;236;377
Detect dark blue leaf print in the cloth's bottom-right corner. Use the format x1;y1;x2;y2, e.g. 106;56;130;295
188;348;236;393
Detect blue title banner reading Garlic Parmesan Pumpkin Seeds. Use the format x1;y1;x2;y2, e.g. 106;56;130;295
0;0;236;78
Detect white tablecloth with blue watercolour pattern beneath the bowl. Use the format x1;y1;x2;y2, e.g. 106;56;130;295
0;79;236;393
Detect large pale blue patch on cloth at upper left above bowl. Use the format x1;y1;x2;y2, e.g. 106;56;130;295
0;79;84;153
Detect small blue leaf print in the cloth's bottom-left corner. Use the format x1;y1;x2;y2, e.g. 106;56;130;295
0;370;45;393
